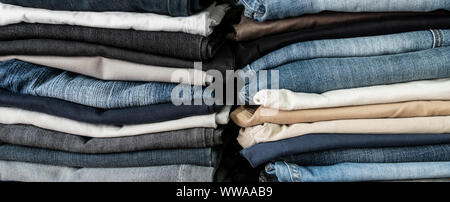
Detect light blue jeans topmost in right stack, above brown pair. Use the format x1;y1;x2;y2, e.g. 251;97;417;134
238;0;450;21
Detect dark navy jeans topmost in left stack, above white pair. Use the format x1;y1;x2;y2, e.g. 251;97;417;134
0;0;212;16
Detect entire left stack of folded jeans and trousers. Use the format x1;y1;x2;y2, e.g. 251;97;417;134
0;0;234;181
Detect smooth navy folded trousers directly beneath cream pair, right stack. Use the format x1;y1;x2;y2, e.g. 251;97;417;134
241;134;450;167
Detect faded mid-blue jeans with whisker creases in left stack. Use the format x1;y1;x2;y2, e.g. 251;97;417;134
0;60;211;109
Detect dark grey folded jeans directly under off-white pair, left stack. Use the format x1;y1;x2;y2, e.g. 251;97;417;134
0;124;224;154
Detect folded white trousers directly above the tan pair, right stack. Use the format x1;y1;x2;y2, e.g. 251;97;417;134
254;79;450;110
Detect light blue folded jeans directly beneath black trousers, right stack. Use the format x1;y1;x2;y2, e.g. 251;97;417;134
243;30;450;72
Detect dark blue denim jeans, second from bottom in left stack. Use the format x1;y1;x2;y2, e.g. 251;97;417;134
0;145;218;168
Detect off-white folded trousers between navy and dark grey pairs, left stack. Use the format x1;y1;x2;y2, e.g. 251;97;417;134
0;106;231;138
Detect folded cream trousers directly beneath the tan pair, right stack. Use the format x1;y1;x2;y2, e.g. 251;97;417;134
238;116;450;148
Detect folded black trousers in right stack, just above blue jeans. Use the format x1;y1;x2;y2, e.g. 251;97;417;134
236;12;450;68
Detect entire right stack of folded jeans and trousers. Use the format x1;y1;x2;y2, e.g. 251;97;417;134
232;0;450;182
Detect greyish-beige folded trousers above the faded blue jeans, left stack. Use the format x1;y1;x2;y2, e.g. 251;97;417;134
0;55;214;86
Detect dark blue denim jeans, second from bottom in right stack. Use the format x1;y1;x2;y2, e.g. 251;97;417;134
277;144;450;166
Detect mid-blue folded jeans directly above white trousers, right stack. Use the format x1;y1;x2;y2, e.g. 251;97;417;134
239;47;450;101
